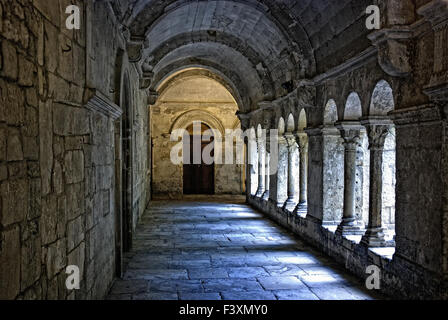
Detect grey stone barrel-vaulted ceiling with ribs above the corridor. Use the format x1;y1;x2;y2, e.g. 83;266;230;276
122;0;369;111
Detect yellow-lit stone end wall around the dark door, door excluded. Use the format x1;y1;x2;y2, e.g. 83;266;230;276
150;75;245;199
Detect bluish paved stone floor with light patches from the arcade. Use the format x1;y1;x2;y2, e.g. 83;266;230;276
108;199;384;300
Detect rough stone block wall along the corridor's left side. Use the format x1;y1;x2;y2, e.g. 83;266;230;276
0;0;147;299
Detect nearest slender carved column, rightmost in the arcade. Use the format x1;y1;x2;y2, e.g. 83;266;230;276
361;120;392;247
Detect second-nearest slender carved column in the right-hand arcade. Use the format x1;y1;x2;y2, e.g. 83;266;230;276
336;121;363;235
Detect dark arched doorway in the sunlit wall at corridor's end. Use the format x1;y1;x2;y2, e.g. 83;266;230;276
183;124;215;195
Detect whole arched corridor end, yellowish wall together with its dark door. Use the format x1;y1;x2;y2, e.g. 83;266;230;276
150;68;243;199
